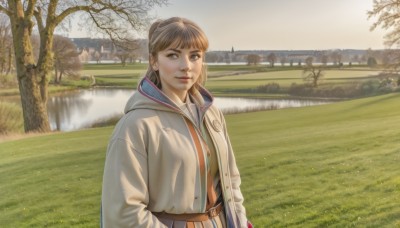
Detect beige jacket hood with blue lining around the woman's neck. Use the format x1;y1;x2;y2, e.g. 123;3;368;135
124;77;214;117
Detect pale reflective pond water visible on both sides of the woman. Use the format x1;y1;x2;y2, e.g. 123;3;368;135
47;89;326;131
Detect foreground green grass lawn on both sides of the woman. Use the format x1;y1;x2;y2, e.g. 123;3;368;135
0;93;400;227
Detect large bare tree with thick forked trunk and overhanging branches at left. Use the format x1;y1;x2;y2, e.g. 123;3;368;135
0;0;167;132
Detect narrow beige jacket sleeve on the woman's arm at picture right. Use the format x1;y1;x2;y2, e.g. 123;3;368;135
220;113;247;228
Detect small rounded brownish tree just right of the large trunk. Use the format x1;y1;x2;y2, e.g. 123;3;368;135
53;35;82;84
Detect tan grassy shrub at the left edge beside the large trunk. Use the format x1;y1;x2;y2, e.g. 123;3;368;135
0;101;24;135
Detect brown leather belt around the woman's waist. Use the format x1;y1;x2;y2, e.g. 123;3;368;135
152;203;222;222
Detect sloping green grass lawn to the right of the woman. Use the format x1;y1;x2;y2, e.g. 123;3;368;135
228;94;400;227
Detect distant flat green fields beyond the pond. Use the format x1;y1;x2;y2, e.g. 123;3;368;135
81;64;380;97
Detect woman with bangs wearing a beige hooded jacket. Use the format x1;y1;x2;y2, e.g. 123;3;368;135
102;17;252;228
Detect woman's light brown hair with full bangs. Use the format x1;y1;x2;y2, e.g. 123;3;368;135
146;17;208;94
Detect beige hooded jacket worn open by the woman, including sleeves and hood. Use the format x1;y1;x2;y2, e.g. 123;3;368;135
101;78;247;228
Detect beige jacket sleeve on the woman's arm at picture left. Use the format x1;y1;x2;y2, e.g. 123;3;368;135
101;138;166;228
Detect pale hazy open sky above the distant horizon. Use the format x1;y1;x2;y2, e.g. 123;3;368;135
70;0;386;50
